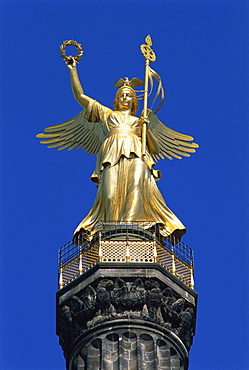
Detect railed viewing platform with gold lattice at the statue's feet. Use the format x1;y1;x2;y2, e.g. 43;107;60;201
58;221;194;289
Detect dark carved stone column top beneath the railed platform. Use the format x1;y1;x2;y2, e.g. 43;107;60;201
57;263;197;370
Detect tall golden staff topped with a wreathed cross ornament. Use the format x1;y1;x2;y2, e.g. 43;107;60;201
140;35;156;155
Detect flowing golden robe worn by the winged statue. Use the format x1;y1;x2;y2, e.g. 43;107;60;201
75;100;186;238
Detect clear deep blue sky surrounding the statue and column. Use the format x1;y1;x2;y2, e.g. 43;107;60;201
0;0;249;370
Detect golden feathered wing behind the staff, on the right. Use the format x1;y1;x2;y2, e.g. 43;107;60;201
148;112;199;161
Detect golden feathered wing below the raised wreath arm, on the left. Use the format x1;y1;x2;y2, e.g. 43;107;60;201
36;109;106;155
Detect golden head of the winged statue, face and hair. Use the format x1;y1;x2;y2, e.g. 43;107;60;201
114;86;138;115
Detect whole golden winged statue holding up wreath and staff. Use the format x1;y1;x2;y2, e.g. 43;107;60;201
37;36;198;239
